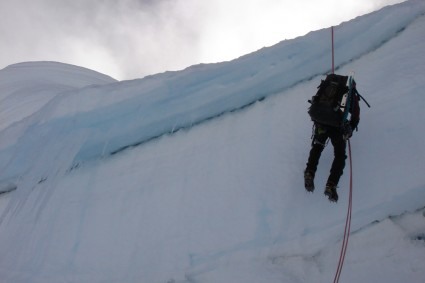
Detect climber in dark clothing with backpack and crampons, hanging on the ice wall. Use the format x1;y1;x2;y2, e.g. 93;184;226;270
304;74;361;202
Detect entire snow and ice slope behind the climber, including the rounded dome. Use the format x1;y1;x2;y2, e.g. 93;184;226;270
0;0;425;283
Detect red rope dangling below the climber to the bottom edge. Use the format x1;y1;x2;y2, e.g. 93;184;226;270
334;140;353;283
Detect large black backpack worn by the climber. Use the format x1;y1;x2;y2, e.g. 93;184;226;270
308;74;350;127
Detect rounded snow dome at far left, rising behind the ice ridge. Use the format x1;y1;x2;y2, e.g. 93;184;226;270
0;62;116;130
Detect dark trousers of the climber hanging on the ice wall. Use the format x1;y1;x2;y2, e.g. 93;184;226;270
306;124;347;185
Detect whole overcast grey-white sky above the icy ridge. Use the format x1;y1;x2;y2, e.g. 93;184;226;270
0;0;403;80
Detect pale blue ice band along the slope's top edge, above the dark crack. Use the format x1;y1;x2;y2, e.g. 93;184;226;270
0;1;425;183
